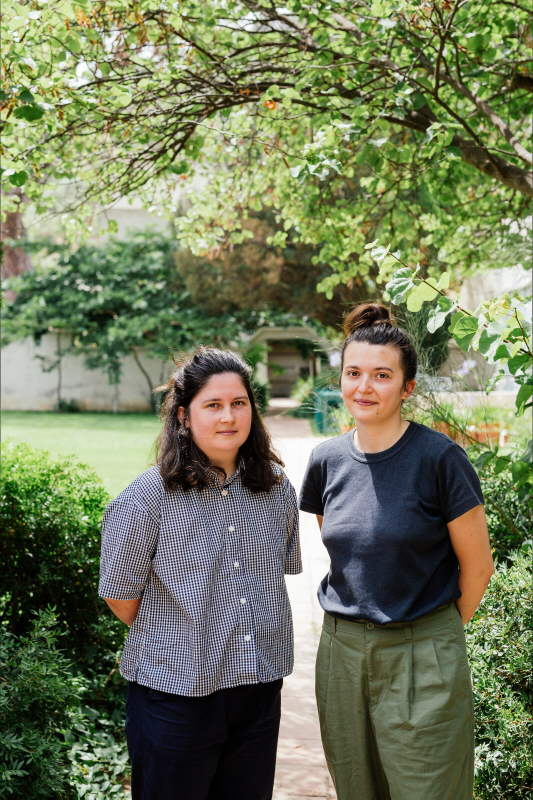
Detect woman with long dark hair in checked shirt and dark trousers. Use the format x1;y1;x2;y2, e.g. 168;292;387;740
99;347;302;800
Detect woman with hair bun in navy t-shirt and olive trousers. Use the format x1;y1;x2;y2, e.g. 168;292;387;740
300;303;494;800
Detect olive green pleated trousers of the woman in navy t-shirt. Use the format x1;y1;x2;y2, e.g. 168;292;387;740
316;603;474;800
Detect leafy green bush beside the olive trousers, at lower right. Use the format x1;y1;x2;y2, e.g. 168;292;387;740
466;553;533;800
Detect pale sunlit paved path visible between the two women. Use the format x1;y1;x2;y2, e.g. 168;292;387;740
266;408;335;800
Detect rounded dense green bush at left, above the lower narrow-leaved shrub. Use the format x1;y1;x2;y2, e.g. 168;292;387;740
0;443;125;670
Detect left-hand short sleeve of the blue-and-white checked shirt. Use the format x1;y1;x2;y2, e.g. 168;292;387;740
98;493;159;600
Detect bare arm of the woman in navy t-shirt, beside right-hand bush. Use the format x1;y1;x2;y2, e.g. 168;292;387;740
448;505;494;625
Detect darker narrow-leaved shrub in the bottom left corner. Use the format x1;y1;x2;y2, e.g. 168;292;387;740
0;610;82;800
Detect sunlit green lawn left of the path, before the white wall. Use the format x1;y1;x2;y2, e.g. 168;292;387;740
1;411;161;497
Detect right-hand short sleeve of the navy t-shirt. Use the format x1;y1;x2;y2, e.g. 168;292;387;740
437;443;485;523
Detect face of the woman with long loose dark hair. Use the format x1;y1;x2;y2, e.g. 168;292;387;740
178;372;252;466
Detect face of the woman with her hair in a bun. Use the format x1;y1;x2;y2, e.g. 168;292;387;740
341;342;415;424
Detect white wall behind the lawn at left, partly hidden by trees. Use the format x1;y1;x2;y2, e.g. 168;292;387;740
1;333;168;411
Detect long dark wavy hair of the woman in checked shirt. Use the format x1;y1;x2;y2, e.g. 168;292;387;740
155;347;284;492
